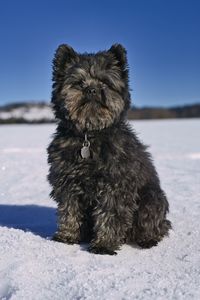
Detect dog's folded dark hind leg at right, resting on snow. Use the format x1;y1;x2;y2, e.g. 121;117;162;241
135;184;171;248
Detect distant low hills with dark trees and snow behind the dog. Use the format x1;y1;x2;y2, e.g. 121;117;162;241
0;102;200;124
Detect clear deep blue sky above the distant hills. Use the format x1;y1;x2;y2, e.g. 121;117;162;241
0;0;200;106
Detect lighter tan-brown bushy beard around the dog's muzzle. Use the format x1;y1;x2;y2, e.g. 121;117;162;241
62;86;124;130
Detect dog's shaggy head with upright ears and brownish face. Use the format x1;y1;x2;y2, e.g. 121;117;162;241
52;44;130;131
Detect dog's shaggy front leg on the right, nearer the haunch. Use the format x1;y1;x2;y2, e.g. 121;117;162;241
89;188;132;255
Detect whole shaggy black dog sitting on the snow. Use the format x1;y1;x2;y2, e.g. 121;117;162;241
48;44;171;255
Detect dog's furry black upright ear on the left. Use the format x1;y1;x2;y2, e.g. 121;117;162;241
53;44;78;81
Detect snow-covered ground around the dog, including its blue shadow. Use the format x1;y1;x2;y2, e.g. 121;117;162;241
0;120;200;300
